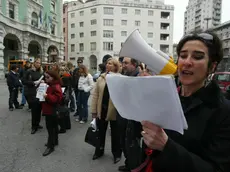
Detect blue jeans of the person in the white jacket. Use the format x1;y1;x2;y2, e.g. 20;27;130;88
77;90;90;122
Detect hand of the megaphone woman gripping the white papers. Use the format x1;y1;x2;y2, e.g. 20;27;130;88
141;121;168;151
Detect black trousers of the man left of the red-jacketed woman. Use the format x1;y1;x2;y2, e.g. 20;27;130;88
30;99;42;129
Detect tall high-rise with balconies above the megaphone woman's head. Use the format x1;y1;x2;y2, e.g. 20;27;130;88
184;0;222;34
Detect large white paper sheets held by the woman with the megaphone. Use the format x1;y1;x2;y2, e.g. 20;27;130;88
106;75;188;134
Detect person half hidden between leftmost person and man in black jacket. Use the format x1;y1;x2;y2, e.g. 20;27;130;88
20;60;31;110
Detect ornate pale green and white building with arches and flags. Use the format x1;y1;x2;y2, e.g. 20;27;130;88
0;0;64;76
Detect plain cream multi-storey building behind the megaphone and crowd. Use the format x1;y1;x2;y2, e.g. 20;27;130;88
68;0;174;71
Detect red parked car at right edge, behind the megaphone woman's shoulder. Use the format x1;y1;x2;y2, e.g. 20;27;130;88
212;72;230;92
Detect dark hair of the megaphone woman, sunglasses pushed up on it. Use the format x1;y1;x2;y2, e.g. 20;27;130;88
177;31;223;64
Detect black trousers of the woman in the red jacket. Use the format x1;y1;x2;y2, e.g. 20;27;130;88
45;115;58;148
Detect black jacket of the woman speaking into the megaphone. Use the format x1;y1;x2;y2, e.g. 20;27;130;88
153;82;230;172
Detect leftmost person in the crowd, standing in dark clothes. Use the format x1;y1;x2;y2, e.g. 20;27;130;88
7;65;22;111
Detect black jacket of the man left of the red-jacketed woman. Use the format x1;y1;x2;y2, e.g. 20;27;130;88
22;69;43;102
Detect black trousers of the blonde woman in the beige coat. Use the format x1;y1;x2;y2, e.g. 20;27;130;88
96;119;122;157
